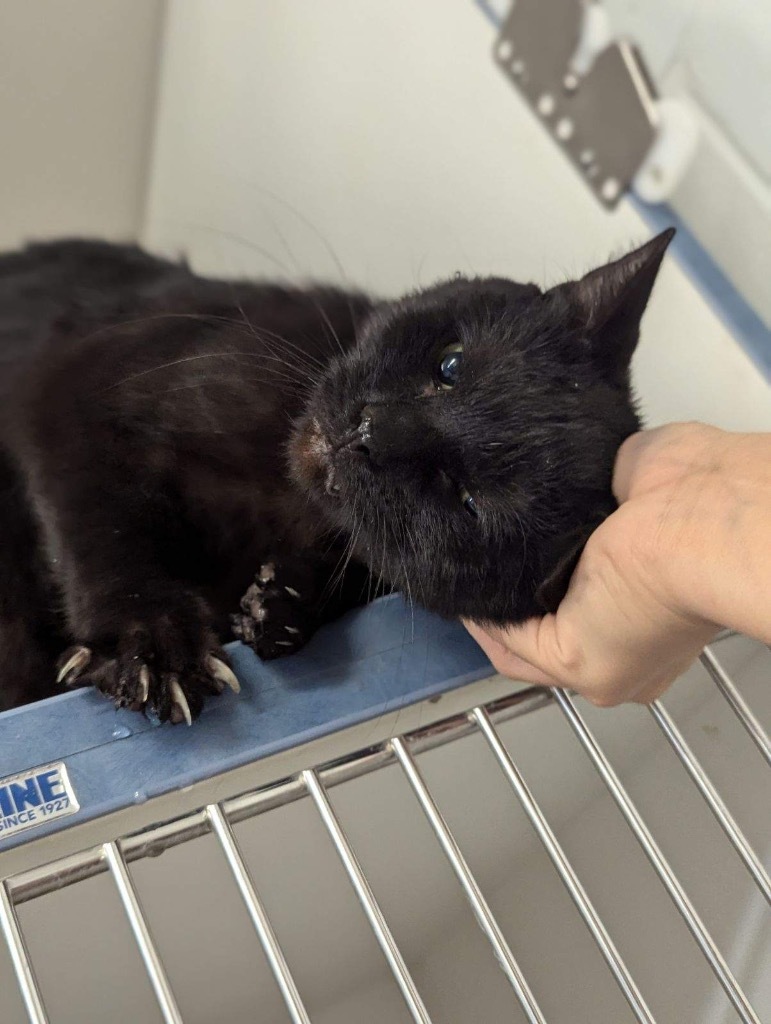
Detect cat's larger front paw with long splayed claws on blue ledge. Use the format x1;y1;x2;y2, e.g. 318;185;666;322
57;616;241;725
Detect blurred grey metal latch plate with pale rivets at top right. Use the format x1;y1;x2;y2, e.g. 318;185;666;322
494;0;658;209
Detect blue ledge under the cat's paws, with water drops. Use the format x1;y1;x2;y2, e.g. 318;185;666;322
0;595;491;852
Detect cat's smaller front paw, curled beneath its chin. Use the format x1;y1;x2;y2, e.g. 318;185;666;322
230;562;315;660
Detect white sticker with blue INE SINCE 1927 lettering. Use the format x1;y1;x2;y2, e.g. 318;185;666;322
0;761;80;843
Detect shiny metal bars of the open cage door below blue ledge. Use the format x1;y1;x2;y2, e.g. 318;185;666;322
0;648;771;1024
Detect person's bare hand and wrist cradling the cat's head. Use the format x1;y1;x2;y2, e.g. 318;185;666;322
465;424;771;708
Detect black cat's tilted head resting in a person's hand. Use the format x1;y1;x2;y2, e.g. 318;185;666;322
290;230;674;623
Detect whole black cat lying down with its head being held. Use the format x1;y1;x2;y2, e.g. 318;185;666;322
0;232;671;721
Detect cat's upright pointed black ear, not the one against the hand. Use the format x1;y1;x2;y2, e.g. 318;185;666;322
547;227;675;375
